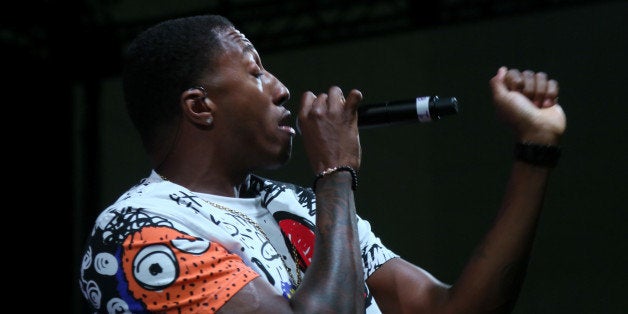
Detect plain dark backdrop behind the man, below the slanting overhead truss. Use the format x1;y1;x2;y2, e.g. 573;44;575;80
65;1;628;313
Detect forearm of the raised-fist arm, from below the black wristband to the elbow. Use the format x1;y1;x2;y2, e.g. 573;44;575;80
450;162;551;313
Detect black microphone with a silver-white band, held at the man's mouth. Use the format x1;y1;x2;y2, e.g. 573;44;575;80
358;95;458;129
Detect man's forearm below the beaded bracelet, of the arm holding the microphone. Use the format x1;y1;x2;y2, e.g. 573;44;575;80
291;171;364;313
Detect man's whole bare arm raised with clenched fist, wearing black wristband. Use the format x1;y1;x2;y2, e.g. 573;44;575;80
368;67;566;314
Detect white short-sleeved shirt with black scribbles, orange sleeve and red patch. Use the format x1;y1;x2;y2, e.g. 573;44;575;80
79;171;397;313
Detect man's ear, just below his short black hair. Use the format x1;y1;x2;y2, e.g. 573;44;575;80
181;88;215;127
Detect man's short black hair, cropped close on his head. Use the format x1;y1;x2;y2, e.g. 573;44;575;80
123;15;234;153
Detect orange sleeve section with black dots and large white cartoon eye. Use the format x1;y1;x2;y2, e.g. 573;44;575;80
121;227;259;313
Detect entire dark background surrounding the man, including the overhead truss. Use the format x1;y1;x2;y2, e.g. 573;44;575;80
8;0;628;314
